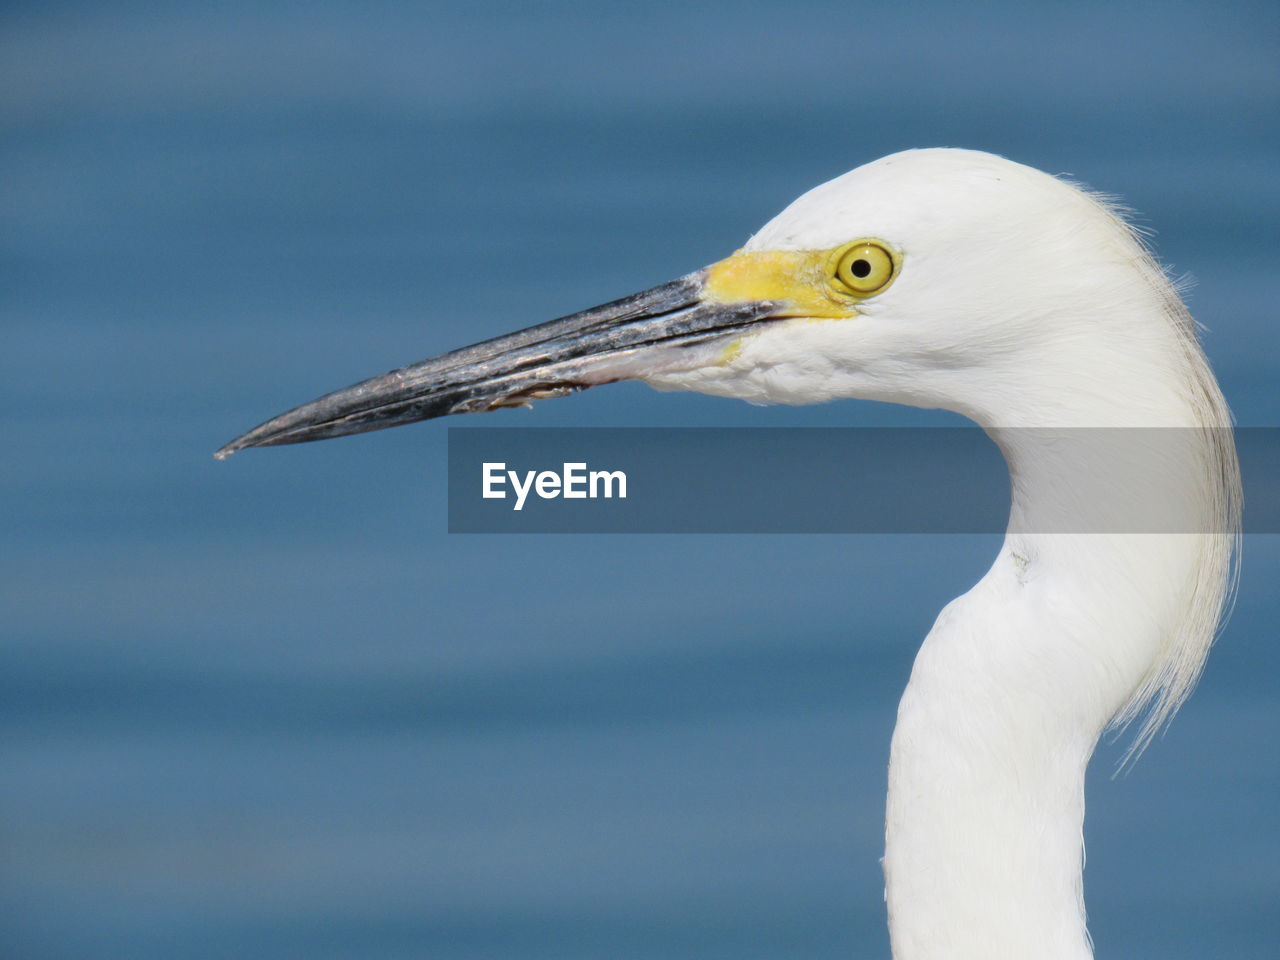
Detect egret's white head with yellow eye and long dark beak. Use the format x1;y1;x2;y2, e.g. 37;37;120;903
218;150;1167;457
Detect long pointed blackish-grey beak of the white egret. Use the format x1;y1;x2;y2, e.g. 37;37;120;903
214;270;787;460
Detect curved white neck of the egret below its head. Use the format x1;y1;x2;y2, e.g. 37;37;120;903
883;293;1234;960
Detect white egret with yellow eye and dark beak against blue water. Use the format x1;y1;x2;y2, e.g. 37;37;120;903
218;150;1240;960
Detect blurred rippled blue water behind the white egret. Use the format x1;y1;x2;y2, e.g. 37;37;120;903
0;0;1280;960
